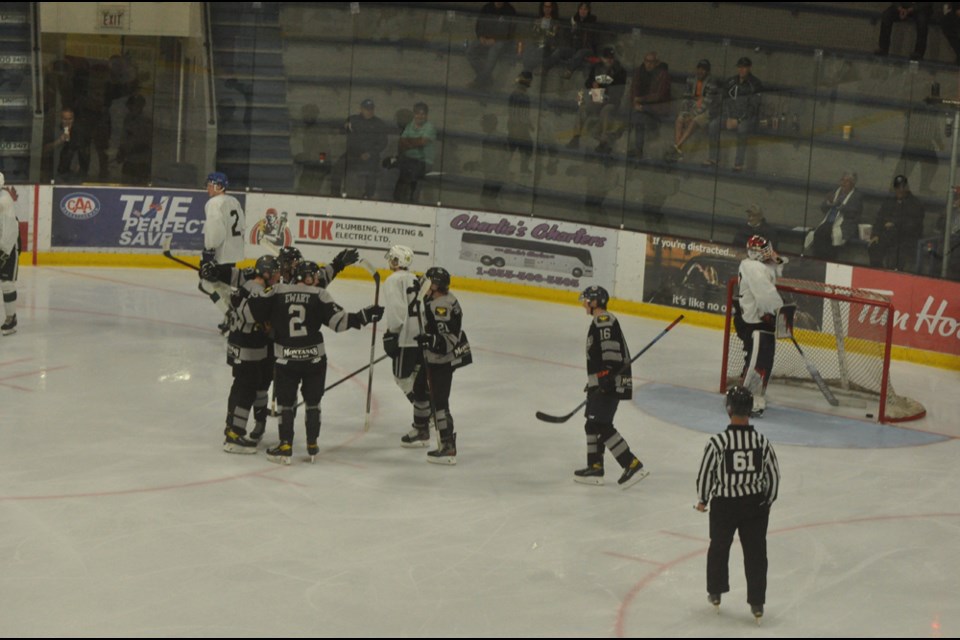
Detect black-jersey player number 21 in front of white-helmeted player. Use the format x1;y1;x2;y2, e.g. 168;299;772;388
413;267;472;464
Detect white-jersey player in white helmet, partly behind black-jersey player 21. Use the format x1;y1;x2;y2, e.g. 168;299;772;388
383;244;430;447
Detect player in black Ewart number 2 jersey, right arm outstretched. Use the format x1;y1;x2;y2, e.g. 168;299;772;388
250;260;383;464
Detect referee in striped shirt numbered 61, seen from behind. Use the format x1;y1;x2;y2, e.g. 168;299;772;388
696;386;780;624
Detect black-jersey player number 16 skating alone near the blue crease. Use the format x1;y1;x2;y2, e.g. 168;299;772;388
573;286;648;489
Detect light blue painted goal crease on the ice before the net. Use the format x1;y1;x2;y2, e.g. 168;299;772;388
633;383;949;449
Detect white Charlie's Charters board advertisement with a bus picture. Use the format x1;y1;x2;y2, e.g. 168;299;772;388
437;209;617;291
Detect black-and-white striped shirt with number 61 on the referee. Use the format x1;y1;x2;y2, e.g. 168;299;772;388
697;424;780;504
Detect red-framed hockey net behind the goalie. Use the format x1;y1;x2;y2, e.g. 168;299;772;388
720;278;926;422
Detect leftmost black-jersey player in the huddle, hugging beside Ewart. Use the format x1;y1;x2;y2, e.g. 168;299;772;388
200;256;280;454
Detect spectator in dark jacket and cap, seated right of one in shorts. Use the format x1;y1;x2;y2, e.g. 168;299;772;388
706;57;763;171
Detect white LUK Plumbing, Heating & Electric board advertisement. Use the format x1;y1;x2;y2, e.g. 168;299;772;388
246;194;434;271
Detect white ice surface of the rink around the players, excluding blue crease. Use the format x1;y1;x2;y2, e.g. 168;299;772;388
0;264;960;638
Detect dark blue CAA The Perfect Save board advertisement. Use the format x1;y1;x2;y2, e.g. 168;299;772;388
50;187;238;251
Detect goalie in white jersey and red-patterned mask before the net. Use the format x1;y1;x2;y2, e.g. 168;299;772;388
733;236;786;417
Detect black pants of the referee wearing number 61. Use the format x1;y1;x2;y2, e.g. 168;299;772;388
707;495;770;605
